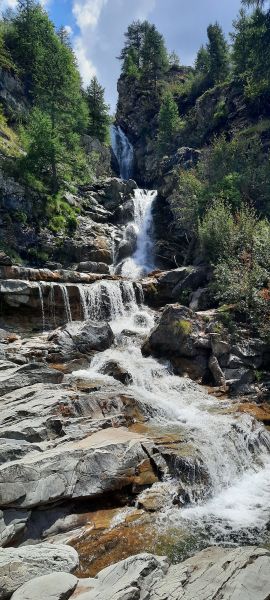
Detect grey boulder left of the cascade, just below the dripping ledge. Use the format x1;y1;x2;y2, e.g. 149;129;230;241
49;321;114;361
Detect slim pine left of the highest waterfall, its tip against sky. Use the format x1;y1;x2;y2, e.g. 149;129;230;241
86;77;110;143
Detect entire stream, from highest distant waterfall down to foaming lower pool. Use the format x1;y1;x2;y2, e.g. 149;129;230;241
71;128;270;548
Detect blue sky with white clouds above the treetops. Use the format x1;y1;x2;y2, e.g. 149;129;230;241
0;0;241;112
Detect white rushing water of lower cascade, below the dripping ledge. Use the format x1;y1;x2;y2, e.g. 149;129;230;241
76;302;270;543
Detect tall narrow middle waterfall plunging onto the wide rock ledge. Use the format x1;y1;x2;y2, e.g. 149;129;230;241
120;189;157;279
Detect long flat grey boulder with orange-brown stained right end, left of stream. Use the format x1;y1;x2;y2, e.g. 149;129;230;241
0;427;159;508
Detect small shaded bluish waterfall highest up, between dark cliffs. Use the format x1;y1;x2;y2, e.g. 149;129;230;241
111;125;134;179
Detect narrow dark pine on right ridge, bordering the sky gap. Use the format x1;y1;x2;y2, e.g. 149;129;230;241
207;23;229;85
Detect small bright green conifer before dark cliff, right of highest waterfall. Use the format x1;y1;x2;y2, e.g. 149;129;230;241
158;92;181;155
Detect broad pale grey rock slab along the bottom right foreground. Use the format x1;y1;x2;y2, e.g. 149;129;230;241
69;547;270;600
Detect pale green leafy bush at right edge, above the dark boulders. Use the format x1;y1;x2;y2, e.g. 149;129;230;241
199;200;270;335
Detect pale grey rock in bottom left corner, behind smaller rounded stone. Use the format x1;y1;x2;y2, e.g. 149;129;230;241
0;543;79;600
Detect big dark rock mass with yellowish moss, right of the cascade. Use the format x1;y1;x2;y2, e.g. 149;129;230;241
142;304;268;395
